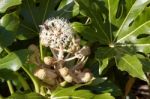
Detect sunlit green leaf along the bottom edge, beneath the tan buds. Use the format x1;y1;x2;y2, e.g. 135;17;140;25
51;85;115;99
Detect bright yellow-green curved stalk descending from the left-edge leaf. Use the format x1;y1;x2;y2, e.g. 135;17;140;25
22;66;40;93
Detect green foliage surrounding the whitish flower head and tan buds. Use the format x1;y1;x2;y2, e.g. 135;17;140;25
0;0;150;99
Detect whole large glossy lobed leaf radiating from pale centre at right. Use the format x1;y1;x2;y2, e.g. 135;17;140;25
73;0;150;81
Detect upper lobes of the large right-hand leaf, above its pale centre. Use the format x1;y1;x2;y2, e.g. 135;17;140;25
76;0;150;53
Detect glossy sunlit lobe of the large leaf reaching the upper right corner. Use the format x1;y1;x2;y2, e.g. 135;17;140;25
115;0;150;42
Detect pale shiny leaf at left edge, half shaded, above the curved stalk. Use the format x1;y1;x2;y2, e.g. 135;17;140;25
0;50;27;71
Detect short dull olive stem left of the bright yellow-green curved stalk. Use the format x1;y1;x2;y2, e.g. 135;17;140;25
15;72;30;90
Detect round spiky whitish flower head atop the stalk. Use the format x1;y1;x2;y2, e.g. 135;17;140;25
40;18;74;48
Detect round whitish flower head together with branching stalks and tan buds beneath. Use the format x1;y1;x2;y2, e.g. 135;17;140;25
37;18;92;83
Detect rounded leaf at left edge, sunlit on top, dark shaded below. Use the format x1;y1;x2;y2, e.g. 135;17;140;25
0;12;19;48
